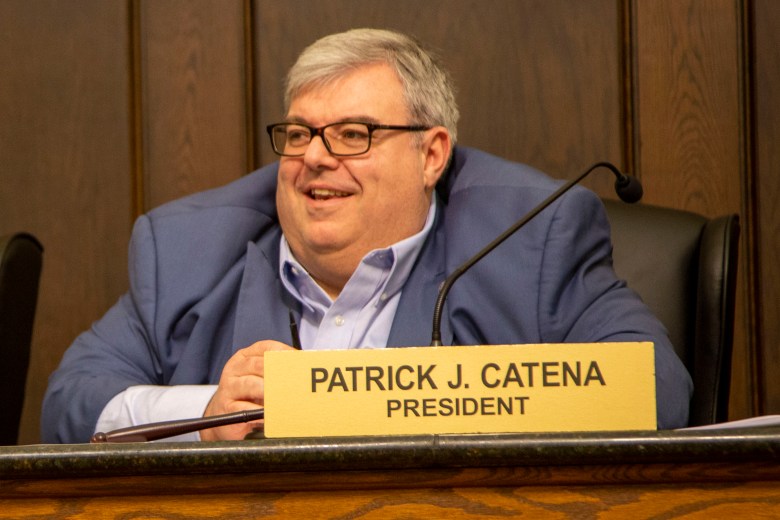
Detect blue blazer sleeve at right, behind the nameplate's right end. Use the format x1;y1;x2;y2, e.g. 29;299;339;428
538;189;693;429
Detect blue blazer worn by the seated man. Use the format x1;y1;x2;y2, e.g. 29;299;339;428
42;147;692;443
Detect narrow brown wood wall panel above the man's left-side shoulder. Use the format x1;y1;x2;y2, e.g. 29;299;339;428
139;0;251;210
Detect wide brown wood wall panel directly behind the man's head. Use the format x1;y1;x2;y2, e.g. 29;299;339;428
255;0;622;192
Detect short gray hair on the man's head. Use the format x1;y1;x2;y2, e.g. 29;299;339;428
284;29;459;144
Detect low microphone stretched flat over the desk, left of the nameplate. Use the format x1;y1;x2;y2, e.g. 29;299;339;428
89;408;265;444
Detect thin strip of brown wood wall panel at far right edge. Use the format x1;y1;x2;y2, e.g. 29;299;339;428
753;0;780;413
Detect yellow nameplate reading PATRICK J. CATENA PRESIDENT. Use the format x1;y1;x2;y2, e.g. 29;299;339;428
265;342;656;437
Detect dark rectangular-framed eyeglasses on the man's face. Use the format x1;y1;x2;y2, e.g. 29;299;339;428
266;121;431;157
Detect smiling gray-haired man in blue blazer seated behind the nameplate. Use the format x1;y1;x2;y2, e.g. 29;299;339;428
42;30;691;442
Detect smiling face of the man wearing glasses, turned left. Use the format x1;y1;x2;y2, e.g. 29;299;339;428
276;64;449;290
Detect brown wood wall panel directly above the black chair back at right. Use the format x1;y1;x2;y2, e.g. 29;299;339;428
633;0;753;417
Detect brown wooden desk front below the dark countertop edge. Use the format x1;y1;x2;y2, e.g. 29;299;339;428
0;464;780;519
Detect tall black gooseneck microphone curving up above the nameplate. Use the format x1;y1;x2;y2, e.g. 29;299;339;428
431;161;642;347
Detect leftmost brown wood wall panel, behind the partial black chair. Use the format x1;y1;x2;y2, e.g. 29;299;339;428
0;0;131;442
